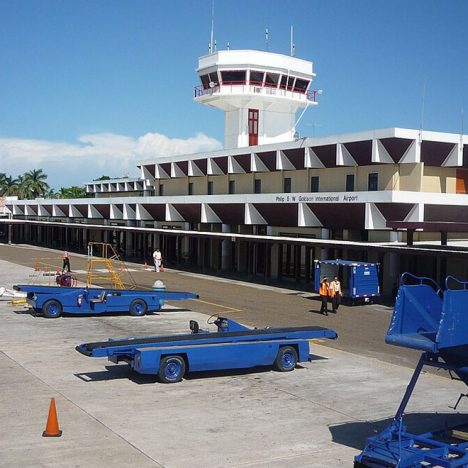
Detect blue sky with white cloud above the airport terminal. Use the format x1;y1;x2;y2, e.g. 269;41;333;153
0;0;468;190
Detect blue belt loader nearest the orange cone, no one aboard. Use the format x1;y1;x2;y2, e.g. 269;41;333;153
76;316;337;383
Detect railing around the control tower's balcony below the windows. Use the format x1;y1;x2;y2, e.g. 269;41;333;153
194;81;318;102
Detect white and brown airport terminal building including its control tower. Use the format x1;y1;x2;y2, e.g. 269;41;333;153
0;50;468;294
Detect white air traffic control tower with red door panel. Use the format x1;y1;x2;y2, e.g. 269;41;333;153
194;50;317;149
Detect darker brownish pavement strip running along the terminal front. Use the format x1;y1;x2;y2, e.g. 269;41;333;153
0;244;419;368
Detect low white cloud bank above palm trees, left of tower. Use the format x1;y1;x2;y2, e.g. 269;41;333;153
0;133;221;188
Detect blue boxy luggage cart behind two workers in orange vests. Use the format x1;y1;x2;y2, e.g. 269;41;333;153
314;260;380;302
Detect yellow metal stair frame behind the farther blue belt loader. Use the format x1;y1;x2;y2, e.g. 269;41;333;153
86;242;136;289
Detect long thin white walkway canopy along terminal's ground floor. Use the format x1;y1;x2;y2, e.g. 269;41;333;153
0;219;468;258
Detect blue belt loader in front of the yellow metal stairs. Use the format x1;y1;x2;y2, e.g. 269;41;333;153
14;285;198;318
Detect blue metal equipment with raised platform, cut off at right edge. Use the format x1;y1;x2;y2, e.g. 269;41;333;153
354;273;468;468
